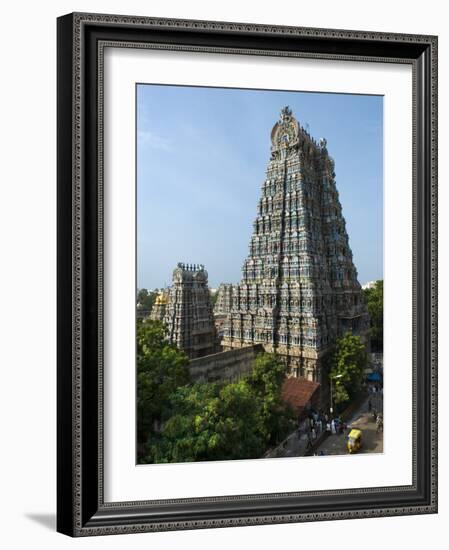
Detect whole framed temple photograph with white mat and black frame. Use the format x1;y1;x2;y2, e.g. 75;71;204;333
57;13;437;536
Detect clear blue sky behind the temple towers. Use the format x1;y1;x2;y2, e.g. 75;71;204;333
137;84;383;288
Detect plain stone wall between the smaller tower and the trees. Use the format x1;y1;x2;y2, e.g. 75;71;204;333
188;344;263;382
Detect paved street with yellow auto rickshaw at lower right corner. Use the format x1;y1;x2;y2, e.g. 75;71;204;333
315;393;383;455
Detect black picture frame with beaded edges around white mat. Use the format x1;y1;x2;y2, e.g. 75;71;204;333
57;13;437;536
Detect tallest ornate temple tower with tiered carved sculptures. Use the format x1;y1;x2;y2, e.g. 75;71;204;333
222;107;369;382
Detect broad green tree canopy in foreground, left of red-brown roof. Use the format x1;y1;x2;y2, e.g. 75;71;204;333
141;354;293;463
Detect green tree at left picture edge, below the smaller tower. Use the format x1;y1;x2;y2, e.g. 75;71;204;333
136;321;189;458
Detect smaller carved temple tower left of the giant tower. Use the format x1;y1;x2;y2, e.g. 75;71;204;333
164;263;216;359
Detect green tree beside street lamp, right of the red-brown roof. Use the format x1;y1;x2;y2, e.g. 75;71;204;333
329;333;368;405
